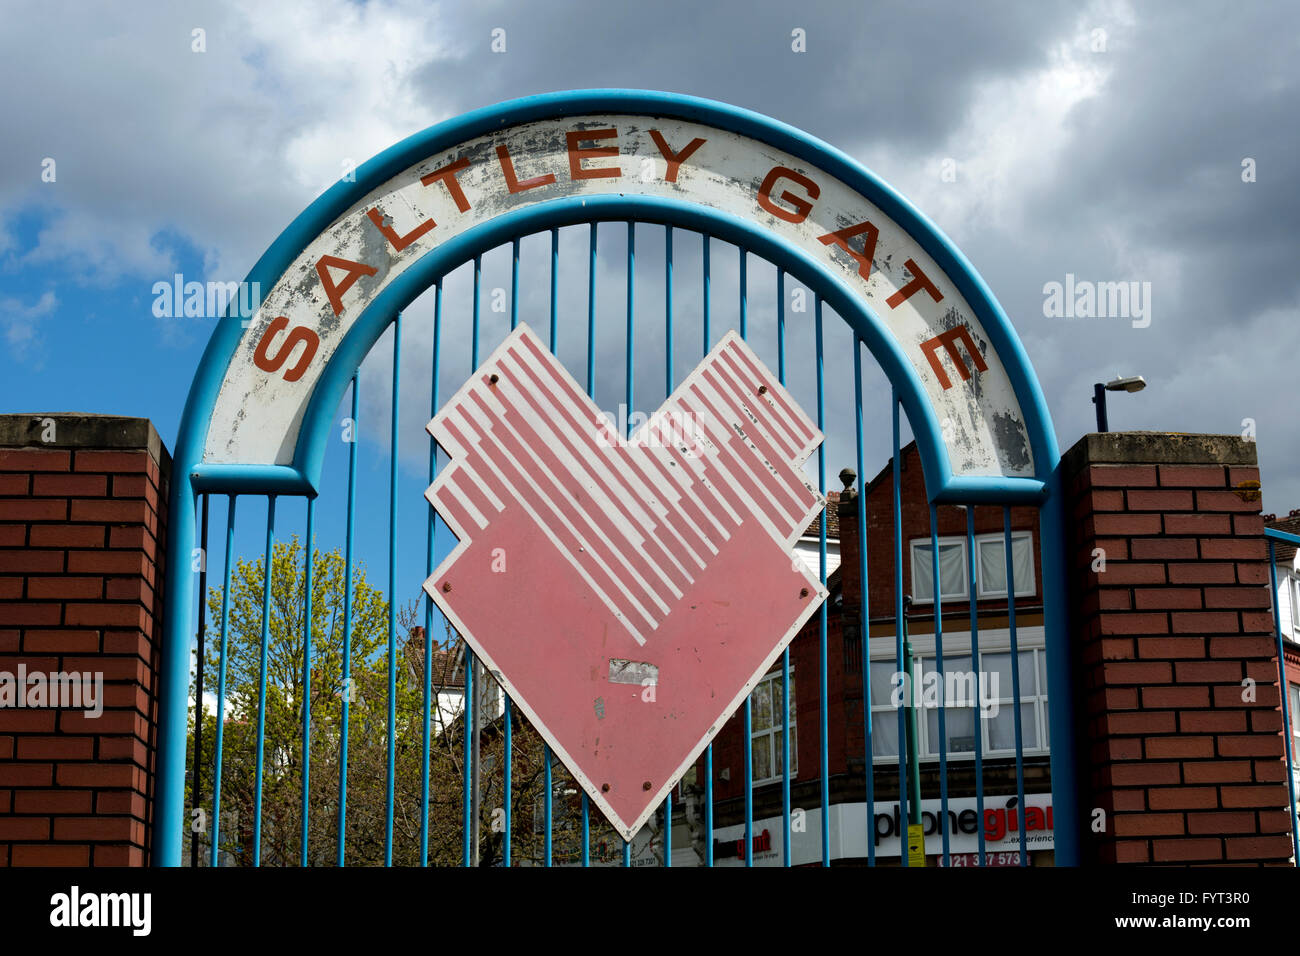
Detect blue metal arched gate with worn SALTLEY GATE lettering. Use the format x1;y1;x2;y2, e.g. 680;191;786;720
153;91;1080;865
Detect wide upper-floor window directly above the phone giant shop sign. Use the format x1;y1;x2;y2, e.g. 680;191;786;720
871;627;1052;761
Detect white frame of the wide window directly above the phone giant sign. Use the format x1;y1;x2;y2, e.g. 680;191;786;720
867;624;1052;765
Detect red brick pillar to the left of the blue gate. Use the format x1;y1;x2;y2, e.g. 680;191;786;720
0;415;170;866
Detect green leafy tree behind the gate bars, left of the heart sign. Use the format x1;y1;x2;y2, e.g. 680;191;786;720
186;536;598;866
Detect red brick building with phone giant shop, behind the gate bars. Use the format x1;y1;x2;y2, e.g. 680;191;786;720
681;444;1052;865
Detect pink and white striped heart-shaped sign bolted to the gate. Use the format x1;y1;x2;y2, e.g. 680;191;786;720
425;325;827;840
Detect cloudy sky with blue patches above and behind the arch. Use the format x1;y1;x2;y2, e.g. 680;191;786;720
0;0;1300;582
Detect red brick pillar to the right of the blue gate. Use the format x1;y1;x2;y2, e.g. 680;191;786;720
1065;433;1292;864
